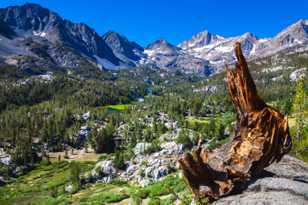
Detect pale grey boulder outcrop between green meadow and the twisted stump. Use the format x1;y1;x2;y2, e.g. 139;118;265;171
81;142;183;187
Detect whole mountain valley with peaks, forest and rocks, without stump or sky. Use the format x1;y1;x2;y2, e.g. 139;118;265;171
0;3;308;205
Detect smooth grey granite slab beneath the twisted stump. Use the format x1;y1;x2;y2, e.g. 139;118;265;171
213;155;308;205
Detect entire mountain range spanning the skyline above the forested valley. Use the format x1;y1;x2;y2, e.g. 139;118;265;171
0;4;308;75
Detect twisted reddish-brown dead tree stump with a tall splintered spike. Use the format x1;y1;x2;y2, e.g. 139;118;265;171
179;43;292;203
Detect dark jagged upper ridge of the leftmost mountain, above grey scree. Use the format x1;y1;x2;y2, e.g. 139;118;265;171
0;4;117;60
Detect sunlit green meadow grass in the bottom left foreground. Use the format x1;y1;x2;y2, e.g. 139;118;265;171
0;161;190;205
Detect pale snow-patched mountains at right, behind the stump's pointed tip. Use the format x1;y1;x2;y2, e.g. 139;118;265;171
178;20;308;70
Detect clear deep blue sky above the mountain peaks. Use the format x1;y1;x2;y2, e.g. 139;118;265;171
0;0;308;46
